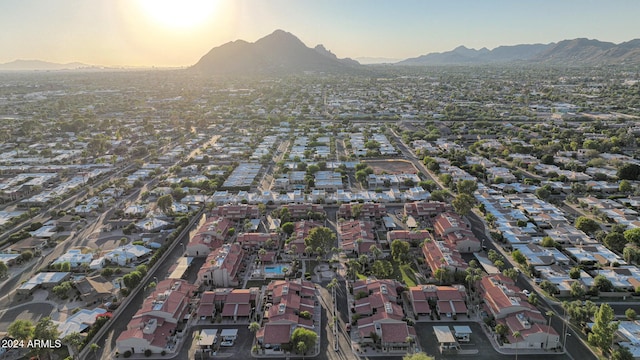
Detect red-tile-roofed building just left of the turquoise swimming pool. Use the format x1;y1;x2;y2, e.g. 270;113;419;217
196;243;245;287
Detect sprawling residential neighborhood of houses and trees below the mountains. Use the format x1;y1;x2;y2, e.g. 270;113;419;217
0;67;640;360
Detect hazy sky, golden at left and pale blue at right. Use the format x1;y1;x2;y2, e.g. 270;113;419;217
0;0;640;67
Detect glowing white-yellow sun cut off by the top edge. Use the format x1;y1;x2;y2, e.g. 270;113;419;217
138;0;216;29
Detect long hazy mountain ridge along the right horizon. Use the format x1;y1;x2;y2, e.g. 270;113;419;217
397;39;640;65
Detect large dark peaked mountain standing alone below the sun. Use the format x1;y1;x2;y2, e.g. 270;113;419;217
190;30;361;75
